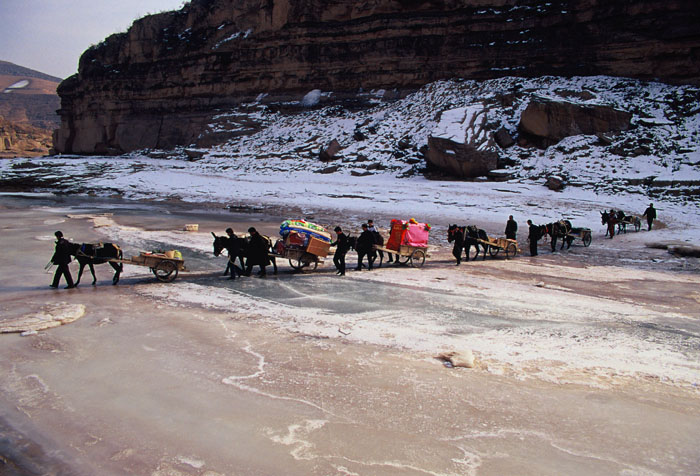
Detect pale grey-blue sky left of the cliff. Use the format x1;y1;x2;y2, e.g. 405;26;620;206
0;0;187;78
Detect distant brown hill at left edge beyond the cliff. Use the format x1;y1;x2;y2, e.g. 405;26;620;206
0;61;61;157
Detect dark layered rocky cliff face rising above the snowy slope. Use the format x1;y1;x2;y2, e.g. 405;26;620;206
54;0;700;154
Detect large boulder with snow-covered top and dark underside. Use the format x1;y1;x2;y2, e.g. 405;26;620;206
425;104;498;178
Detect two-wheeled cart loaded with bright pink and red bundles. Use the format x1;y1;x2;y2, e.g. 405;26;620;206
375;218;431;268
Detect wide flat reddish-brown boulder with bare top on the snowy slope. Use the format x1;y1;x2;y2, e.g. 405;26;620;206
519;97;632;147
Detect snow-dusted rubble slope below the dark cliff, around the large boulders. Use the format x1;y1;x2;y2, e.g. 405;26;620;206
191;76;700;196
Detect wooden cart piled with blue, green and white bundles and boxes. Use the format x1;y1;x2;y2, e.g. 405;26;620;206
272;220;331;271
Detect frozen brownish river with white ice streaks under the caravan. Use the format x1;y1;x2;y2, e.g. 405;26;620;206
0;196;700;476
